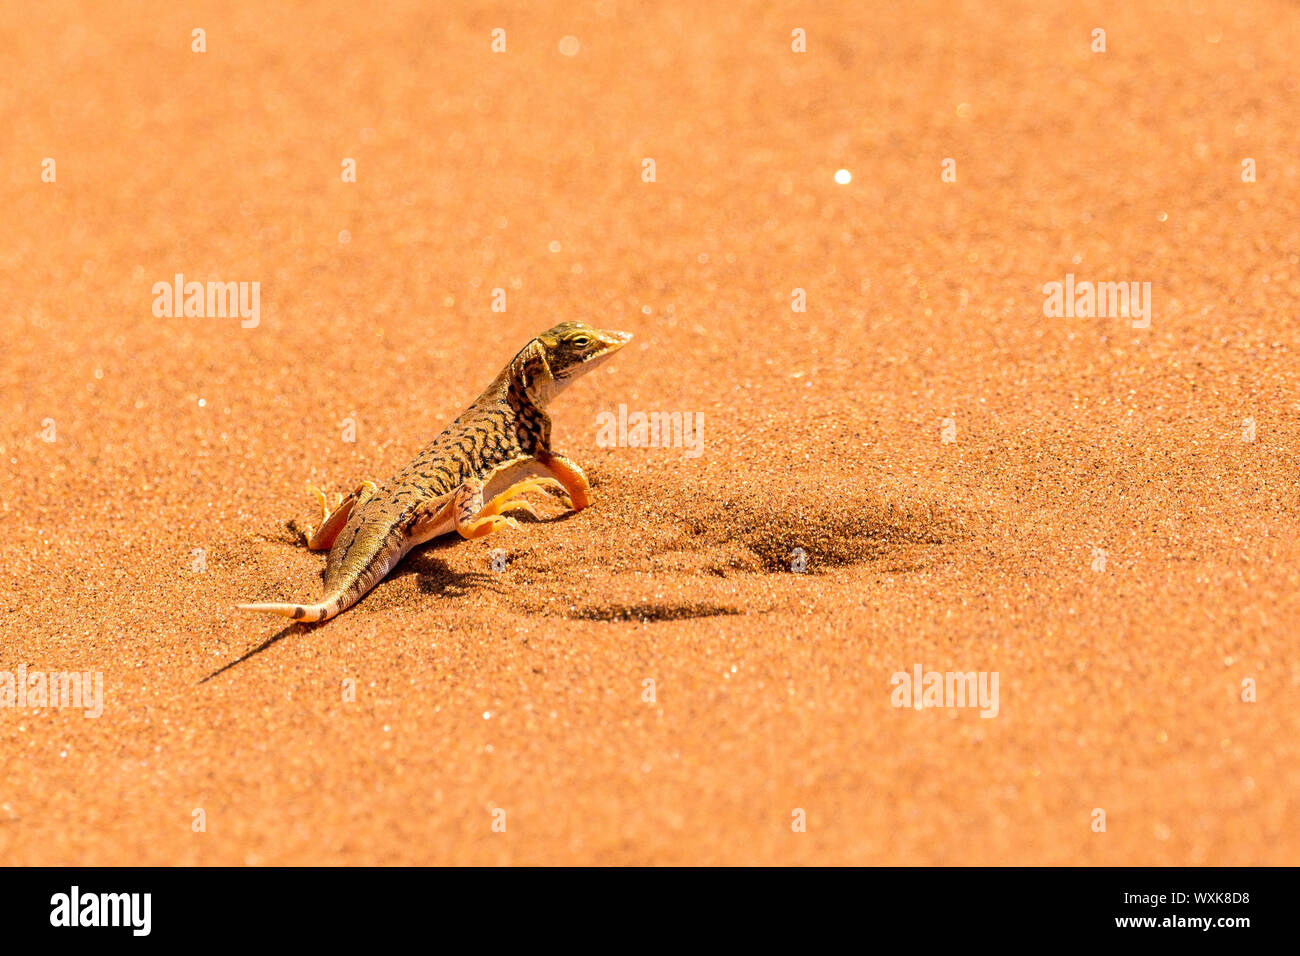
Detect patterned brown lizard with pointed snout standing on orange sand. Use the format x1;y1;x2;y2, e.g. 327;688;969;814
237;321;632;623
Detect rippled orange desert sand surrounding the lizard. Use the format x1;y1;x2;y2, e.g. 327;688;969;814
0;0;1300;865
